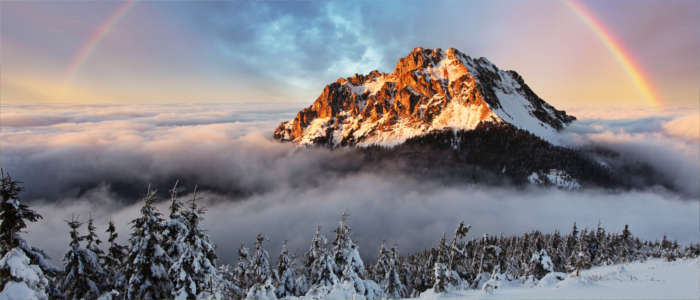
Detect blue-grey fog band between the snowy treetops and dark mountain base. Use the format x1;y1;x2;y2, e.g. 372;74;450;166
23;174;700;263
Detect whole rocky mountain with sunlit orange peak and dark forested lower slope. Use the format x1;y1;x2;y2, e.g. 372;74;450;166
274;48;670;189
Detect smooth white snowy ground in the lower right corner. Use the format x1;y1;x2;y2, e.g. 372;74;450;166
420;258;700;299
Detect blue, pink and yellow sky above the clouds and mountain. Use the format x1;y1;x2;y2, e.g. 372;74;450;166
0;0;700;109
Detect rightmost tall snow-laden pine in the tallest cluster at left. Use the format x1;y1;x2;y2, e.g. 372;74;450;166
170;187;216;299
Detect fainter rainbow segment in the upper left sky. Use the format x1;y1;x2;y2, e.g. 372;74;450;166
63;0;136;86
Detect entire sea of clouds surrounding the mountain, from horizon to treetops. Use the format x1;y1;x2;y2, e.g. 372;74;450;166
0;103;700;262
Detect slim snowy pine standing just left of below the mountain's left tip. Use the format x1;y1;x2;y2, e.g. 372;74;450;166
246;233;276;299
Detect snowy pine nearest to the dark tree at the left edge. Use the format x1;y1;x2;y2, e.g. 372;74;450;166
61;217;104;300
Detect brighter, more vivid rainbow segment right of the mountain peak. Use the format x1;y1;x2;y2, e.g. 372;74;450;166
565;0;661;107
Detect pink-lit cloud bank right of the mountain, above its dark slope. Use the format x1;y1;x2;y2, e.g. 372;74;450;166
565;109;700;198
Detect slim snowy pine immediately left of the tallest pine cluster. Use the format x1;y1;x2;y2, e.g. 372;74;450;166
102;219;127;297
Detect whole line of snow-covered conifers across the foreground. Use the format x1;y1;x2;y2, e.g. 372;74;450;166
0;174;700;300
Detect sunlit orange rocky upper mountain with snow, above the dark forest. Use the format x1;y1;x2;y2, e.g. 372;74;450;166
274;48;575;147
